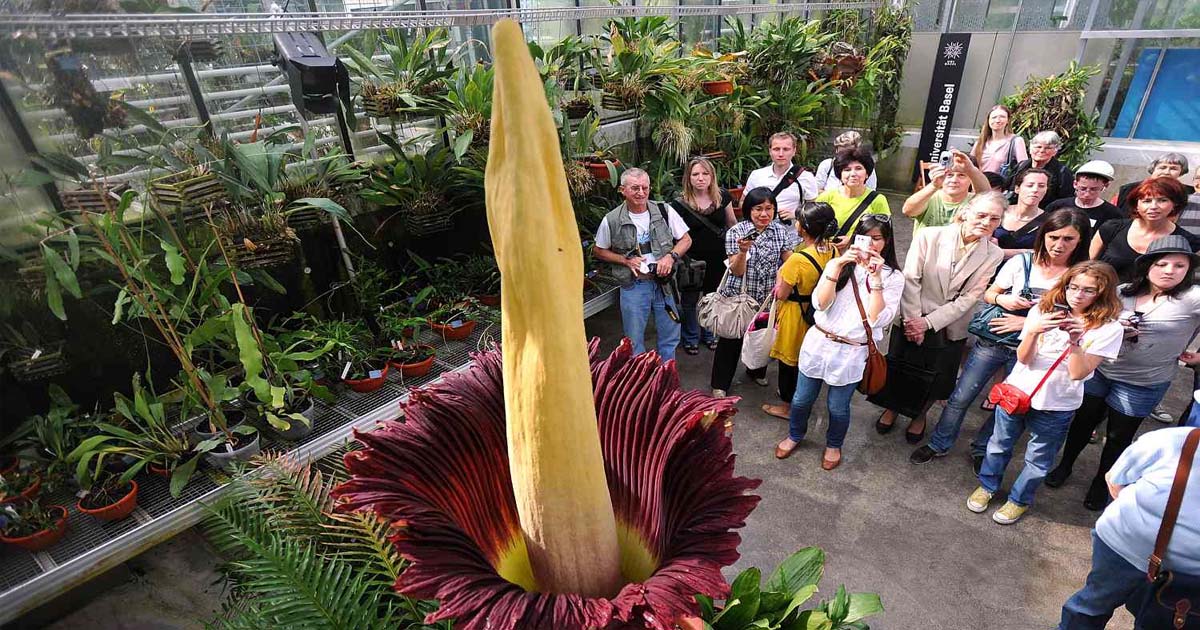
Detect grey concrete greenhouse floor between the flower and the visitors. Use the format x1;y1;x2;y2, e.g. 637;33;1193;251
28;194;1190;630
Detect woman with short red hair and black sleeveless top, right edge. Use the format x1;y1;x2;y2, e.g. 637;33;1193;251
1091;172;1200;282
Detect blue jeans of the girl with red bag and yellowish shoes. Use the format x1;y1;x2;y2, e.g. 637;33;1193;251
979;407;1075;506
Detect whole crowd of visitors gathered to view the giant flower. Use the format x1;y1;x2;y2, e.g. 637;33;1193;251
595;115;1200;629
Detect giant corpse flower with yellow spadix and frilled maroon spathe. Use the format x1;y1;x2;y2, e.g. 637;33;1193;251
335;22;758;630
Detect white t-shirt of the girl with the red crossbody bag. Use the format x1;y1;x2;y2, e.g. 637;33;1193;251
1004;306;1124;412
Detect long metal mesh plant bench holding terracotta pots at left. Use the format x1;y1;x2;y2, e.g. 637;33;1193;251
0;277;618;625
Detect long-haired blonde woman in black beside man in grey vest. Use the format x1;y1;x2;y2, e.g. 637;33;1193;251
671;157;737;354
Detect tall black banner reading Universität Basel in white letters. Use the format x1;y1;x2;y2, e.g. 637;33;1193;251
912;32;971;181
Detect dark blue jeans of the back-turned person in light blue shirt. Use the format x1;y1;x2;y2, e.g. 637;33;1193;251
1058;529;1150;630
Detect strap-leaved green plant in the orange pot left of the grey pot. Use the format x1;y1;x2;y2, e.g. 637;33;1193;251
68;373;199;497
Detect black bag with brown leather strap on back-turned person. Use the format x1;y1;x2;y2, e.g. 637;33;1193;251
1136;428;1200;630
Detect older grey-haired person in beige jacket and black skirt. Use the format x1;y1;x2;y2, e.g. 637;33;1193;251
874;192;1008;444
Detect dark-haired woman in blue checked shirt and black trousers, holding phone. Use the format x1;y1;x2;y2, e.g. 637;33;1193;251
709;186;796;397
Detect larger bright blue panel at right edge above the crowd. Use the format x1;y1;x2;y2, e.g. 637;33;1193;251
1122;48;1200;142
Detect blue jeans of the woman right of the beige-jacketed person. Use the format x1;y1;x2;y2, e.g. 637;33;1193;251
929;340;1016;457
